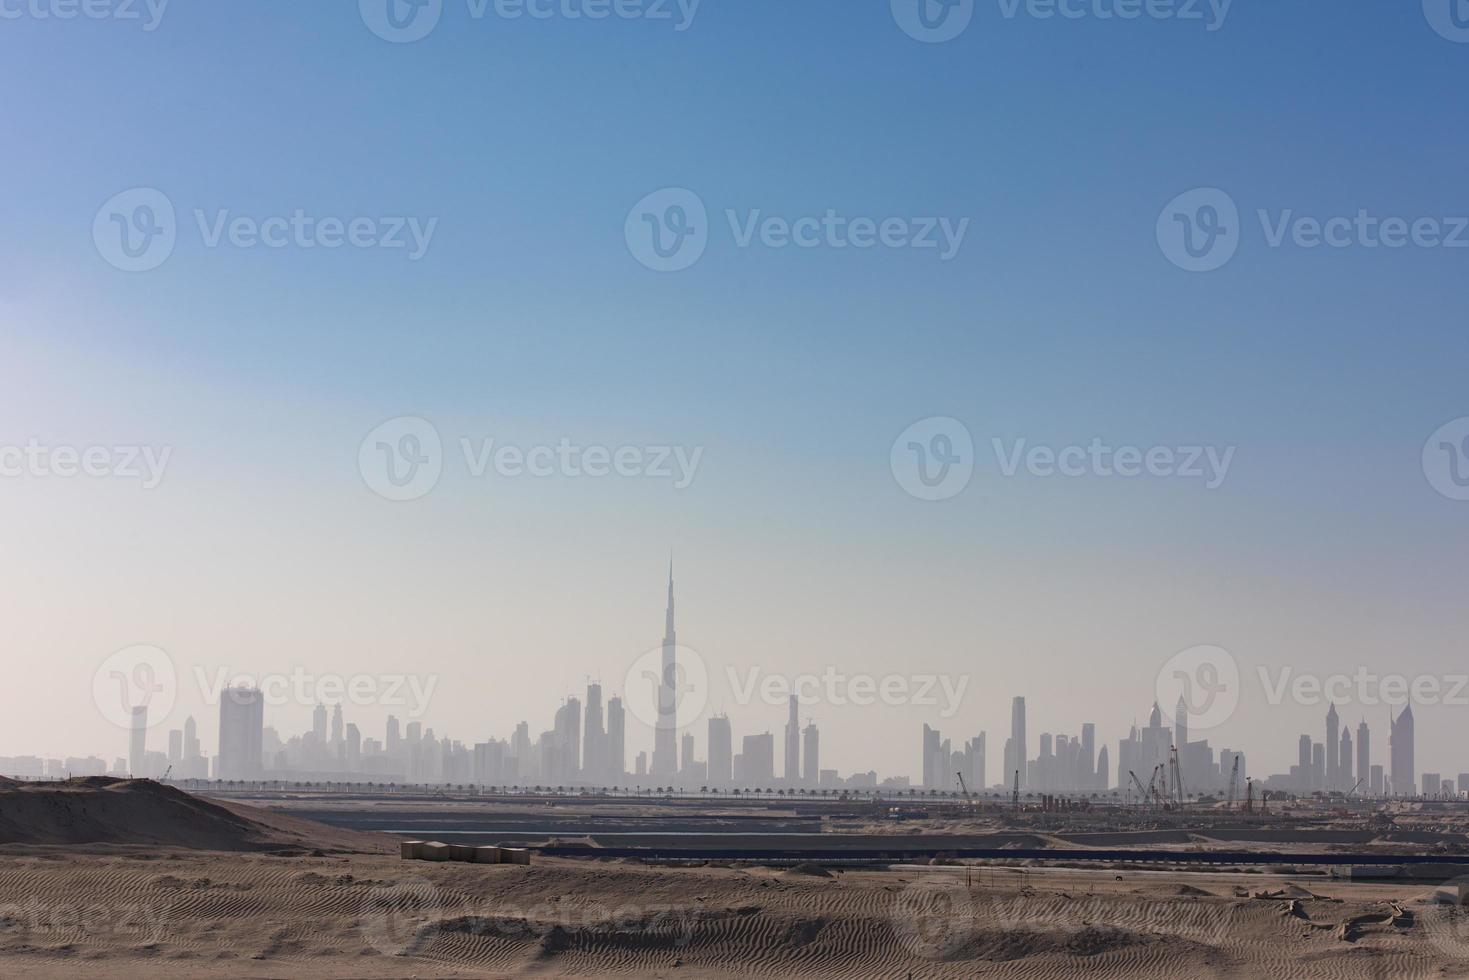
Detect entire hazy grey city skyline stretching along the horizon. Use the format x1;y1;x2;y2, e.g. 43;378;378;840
17;570;1469;796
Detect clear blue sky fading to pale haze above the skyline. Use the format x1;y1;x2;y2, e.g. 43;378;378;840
0;0;1469;776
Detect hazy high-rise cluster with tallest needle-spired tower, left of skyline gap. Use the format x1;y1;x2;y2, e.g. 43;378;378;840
85;567;893;789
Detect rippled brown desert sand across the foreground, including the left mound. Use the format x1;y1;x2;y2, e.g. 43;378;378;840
0;785;1469;980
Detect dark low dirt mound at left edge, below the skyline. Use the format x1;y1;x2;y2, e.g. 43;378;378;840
0;776;391;852
